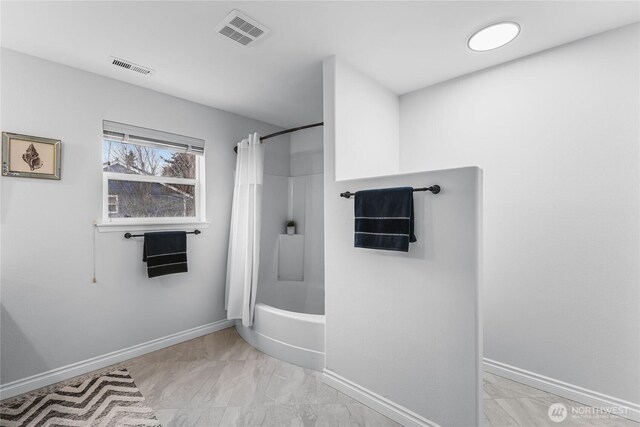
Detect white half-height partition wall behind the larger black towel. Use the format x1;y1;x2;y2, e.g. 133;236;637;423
324;58;482;426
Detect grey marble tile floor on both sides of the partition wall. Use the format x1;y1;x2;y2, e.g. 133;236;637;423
2;328;640;427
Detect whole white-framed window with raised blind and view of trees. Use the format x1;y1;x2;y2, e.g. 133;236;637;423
102;120;204;223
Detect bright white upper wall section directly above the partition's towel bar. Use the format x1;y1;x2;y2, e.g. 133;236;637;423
332;60;399;180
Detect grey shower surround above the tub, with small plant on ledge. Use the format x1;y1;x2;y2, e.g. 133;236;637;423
257;128;324;314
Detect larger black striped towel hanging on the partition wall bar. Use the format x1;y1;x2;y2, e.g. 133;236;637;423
354;187;418;252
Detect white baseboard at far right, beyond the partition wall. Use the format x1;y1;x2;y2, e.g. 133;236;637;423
483;357;640;422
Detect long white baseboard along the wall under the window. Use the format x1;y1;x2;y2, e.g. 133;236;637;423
0;320;234;400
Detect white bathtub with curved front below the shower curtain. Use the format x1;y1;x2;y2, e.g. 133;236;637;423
236;303;325;371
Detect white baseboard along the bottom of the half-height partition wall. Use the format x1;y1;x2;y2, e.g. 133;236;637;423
322;369;440;427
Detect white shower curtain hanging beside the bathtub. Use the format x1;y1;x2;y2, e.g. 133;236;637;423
225;133;264;326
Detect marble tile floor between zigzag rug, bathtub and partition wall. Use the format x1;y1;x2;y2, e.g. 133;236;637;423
123;328;399;427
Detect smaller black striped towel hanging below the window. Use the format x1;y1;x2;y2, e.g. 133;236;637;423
142;231;187;277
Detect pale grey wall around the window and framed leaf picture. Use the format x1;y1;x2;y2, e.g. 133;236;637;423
0;49;288;384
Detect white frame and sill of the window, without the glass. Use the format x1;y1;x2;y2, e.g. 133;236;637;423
99;123;206;226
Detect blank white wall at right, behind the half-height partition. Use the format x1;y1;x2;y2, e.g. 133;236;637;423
400;25;640;404
